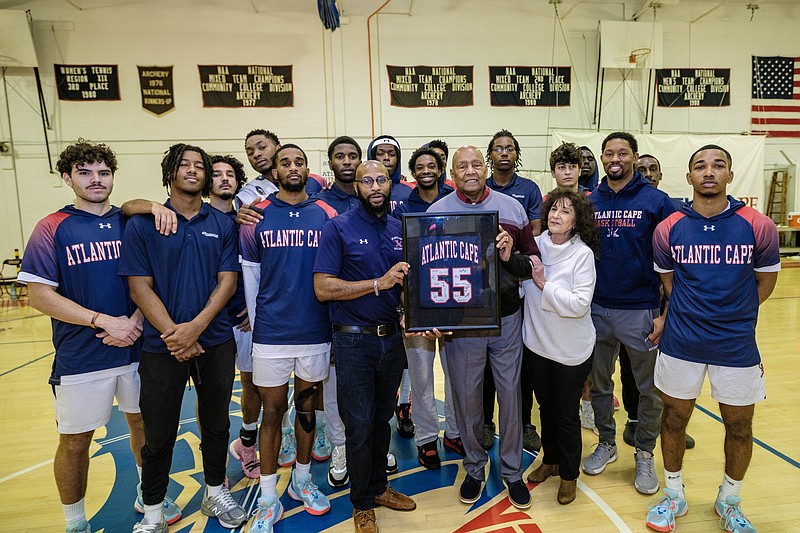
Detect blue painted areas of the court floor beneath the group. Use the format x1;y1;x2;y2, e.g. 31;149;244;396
90;381;535;533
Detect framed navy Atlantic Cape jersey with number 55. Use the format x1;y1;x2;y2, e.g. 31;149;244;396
403;211;500;331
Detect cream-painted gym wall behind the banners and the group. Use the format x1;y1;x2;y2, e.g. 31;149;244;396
0;0;800;257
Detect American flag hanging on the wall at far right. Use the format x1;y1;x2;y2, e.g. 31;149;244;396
751;56;800;137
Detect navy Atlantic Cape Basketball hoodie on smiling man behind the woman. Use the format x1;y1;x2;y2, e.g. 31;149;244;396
589;172;675;309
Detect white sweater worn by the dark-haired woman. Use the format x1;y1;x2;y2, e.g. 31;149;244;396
522;232;596;366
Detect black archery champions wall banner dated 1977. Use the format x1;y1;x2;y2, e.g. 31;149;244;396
197;65;294;107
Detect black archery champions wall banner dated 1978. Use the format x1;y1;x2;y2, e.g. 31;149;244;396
386;65;474;107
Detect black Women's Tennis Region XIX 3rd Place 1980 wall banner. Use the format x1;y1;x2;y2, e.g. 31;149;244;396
54;65;119;102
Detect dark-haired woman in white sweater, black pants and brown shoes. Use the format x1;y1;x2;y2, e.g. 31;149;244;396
507;190;599;504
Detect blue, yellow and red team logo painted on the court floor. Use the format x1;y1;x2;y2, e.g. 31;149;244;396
90;379;541;533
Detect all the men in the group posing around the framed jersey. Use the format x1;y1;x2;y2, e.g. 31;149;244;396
19;130;780;533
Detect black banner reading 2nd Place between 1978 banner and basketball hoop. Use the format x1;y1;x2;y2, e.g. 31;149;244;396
489;66;572;107
